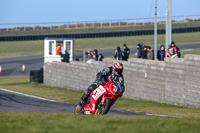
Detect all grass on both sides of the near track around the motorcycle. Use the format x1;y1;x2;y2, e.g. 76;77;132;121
0;77;200;133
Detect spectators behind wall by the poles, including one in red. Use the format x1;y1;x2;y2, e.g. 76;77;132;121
135;41;181;61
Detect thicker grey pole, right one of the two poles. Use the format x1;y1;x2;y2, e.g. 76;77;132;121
165;0;172;56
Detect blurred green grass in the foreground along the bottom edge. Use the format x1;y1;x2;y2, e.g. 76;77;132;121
0;113;200;133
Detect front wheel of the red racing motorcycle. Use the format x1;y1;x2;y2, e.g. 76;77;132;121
95;98;112;115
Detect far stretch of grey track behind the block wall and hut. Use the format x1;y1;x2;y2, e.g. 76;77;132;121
0;43;200;76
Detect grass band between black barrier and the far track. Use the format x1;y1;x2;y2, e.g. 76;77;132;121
0;32;200;57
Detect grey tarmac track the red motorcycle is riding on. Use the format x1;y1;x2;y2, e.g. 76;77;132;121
0;88;145;116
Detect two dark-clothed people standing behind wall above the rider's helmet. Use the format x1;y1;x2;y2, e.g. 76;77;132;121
114;44;130;61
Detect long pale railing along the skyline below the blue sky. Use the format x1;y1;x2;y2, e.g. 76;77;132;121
0;15;200;31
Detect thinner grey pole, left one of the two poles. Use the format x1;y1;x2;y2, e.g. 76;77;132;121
154;0;157;60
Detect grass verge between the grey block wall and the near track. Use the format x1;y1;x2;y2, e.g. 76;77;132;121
0;77;200;118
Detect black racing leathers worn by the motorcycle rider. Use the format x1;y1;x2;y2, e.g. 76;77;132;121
81;67;125;102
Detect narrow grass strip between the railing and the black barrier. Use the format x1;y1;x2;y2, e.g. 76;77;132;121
0;21;200;36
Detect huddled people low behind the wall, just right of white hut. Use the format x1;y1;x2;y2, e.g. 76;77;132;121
85;49;104;61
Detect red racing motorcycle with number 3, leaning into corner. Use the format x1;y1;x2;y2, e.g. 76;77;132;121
75;81;122;115
